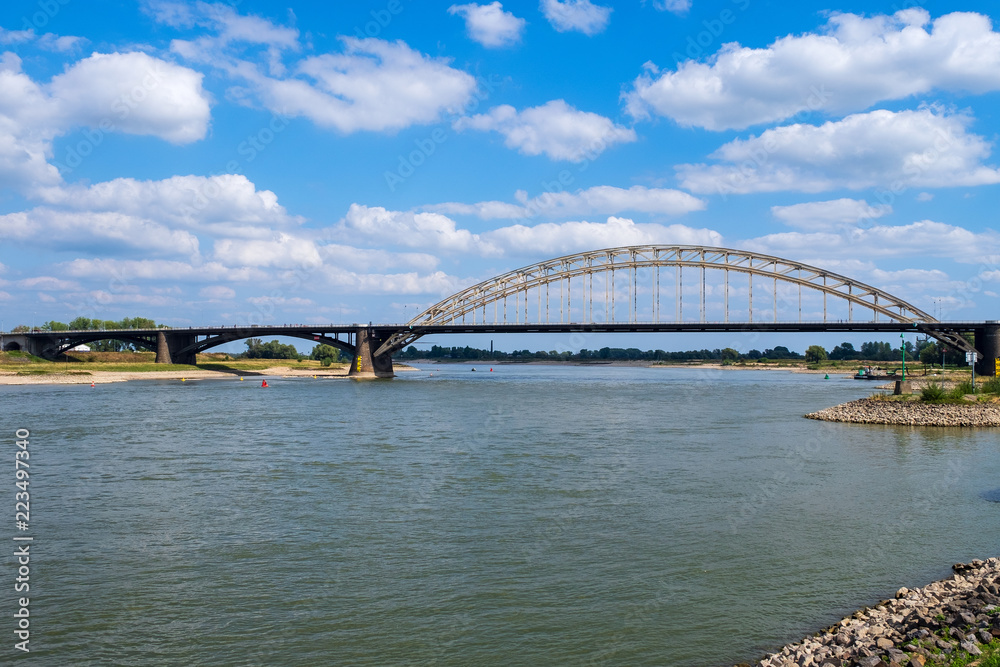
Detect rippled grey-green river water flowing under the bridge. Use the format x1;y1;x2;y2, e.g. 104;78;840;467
0;365;1000;666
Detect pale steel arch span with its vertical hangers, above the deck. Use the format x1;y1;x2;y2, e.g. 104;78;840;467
375;245;974;356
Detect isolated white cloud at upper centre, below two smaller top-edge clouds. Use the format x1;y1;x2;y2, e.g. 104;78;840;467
454;100;636;162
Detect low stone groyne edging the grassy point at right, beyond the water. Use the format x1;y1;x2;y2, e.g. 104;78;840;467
806;398;1000;426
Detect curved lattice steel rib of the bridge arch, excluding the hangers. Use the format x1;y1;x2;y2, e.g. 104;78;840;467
376;245;972;354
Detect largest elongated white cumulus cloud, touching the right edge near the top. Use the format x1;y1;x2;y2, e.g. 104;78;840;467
625;9;1000;130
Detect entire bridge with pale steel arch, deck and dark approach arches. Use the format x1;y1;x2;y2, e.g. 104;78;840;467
2;245;1000;377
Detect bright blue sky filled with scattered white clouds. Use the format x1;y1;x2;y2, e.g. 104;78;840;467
0;0;1000;349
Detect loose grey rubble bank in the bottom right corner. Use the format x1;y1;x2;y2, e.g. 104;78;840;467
756;558;1000;667
